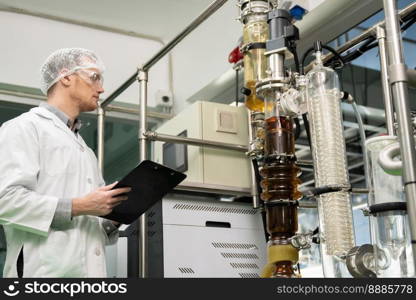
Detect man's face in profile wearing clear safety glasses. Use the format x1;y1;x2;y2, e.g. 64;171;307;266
72;68;104;112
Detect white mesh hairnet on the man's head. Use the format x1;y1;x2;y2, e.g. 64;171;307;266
40;48;104;95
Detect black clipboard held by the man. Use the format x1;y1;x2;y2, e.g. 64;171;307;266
102;160;186;224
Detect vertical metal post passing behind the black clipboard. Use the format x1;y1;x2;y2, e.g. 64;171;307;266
137;69;148;278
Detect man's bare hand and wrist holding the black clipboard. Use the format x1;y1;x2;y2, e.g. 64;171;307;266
72;182;131;217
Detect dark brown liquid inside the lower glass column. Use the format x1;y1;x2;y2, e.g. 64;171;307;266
260;117;301;277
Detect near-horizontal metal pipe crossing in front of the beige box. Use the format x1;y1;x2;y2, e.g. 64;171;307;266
143;131;248;152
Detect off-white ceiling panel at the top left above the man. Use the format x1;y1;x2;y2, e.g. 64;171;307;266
0;0;213;42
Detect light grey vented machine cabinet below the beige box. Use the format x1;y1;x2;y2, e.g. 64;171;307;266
123;193;266;278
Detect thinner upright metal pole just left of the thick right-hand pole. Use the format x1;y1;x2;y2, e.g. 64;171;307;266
377;26;395;135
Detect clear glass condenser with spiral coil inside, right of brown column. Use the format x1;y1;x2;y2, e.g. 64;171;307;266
307;54;355;257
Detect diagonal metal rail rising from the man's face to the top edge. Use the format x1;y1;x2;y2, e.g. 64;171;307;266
101;0;227;109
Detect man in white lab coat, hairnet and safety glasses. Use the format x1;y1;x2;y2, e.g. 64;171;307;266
0;48;130;277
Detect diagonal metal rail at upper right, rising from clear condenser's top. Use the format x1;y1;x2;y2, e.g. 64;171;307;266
305;2;416;73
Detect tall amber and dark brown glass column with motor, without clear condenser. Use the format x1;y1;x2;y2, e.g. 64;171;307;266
239;0;302;277
